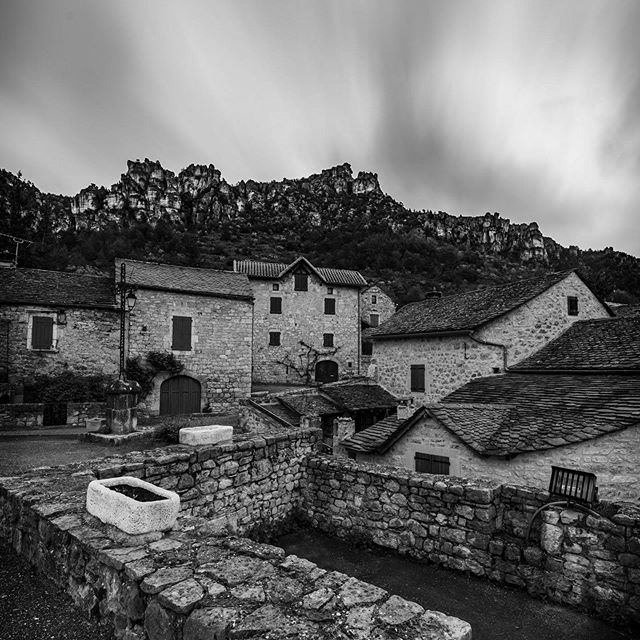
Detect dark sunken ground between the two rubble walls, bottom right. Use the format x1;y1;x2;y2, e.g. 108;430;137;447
273;530;638;640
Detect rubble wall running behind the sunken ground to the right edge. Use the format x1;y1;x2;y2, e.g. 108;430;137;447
303;456;640;624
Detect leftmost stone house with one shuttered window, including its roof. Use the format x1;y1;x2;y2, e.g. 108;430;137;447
0;268;119;390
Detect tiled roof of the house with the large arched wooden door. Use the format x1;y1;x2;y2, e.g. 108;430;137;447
116;259;253;300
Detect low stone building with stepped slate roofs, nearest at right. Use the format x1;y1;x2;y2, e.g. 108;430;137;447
342;317;640;500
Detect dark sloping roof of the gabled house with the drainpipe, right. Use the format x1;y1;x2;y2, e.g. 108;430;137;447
373;271;592;338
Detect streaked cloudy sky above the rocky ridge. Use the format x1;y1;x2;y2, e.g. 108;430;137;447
0;0;640;256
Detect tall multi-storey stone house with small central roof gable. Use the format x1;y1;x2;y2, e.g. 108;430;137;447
233;258;367;384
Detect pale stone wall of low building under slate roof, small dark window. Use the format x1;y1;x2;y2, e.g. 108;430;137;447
356;416;640;500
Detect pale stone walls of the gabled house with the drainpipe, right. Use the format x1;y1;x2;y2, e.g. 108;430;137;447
373;273;609;404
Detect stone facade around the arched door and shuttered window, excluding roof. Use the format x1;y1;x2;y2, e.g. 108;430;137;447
129;289;252;414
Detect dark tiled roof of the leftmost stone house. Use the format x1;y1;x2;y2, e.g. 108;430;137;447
0;269;116;309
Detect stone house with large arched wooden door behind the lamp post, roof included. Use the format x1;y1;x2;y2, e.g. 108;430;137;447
116;260;253;414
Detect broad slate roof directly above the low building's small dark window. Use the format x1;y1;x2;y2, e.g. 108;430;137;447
440;373;640;455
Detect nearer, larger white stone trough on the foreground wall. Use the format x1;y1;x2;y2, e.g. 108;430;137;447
87;476;180;535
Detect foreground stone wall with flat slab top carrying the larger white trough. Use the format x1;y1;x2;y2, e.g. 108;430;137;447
0;430;471;640
